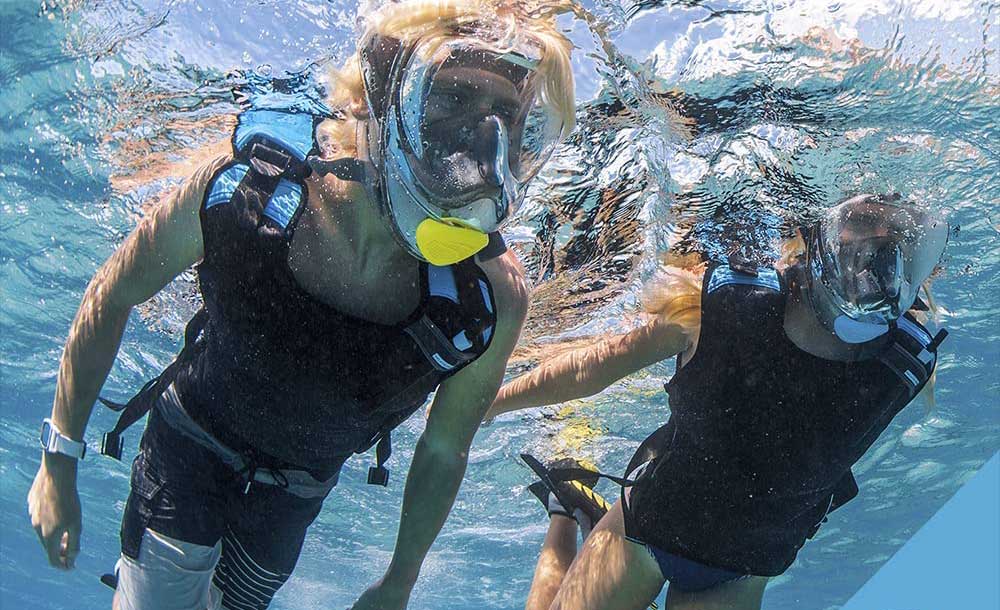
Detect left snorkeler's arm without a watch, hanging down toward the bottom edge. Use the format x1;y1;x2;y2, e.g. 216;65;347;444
354;252;528;610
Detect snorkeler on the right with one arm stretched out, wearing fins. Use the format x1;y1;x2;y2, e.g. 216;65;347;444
488;195;948;610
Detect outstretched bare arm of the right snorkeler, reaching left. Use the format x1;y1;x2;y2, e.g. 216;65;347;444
486;318;689;418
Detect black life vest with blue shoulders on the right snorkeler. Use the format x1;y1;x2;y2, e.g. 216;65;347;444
626;256;946;576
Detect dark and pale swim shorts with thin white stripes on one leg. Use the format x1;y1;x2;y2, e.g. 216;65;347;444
118;387;346;610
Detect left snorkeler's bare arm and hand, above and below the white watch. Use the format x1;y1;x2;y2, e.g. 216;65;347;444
28;158;225;568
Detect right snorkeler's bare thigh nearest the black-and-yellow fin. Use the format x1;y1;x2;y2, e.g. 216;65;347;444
550;501;664;610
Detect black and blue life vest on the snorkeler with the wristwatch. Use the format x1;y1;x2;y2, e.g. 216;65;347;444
102;110;504;484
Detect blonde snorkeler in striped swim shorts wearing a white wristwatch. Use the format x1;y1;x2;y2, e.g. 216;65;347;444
28;1;574;610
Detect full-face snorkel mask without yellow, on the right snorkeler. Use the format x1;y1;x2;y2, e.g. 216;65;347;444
806;195;948;343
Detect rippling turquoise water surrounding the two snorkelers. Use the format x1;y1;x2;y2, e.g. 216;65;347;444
0;0;1000;610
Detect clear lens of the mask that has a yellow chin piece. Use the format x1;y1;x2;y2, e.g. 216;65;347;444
398;39;561;216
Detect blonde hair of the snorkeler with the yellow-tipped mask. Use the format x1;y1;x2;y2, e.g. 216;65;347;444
327;0;576;150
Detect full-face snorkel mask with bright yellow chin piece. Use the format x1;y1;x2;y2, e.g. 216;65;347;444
361;26;563;265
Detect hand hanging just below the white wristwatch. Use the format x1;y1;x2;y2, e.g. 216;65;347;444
28;454;81;570
